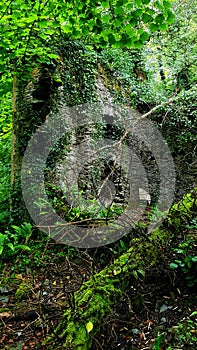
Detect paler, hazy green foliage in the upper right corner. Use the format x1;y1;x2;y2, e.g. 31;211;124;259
144;0;197;96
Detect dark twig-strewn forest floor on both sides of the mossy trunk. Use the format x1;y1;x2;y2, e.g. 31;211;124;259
0;237;197;350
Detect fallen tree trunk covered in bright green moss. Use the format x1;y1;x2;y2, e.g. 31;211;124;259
44;189;197;350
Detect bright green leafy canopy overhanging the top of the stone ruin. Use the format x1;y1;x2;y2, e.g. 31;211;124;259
0;0;174;98
